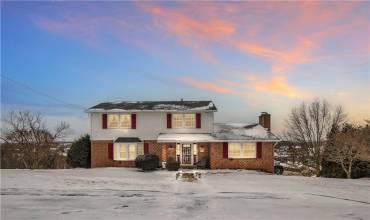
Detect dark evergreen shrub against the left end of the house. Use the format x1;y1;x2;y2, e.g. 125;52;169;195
67;134;91;168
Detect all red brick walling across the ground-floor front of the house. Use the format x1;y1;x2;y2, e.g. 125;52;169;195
91;141;274;173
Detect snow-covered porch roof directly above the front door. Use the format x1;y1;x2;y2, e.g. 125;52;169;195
157;133;215;142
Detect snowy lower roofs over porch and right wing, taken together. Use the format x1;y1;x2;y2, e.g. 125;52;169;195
157;123;279;142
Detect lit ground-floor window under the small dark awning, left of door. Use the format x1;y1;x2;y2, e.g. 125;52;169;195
114;143;143;160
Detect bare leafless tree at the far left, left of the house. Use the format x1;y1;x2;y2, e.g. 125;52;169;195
1;111;69;169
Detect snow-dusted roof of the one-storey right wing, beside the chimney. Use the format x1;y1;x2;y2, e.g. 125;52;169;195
212;123;279;141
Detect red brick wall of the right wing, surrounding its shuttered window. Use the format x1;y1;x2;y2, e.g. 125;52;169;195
210;143;274;173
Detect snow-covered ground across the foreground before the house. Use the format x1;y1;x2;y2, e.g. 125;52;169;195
1;168;370;220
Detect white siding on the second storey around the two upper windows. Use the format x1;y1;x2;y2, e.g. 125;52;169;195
90;112;213;140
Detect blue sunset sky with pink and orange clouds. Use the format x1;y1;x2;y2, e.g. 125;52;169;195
1;1;370;139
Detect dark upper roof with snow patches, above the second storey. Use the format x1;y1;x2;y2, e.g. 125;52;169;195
87;101;217;112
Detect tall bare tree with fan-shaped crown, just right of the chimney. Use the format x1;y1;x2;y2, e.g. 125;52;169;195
286;100;345;176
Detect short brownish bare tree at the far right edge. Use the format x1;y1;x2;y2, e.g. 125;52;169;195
327;122;370;179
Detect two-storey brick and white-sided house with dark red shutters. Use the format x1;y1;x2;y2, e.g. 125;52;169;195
87;100;279;172
